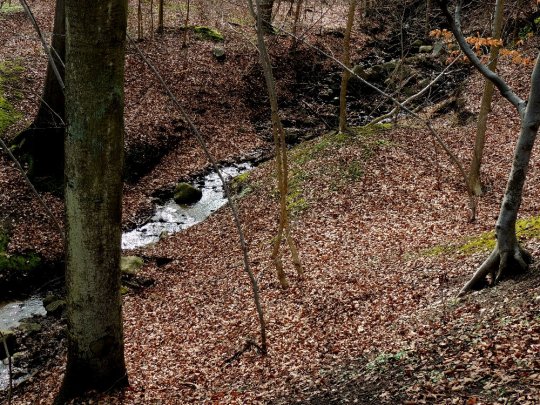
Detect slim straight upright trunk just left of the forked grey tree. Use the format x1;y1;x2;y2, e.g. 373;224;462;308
469;0;504;195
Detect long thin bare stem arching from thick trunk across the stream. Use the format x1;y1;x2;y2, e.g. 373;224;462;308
126;34;267;354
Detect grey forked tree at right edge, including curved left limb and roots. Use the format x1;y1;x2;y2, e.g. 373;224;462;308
437;0;540;295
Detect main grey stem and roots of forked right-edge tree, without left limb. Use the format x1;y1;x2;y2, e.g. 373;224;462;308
460;55;540;295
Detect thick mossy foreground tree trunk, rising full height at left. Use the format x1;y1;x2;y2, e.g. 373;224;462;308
59;0;127;402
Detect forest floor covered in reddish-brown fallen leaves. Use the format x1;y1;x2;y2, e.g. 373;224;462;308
0;1;540;404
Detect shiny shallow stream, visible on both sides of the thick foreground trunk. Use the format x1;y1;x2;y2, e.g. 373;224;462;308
0;162;253;391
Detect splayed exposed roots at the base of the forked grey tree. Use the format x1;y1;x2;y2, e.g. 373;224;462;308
458;242;533;297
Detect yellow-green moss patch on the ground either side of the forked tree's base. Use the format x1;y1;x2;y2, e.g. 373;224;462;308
422;216;540;256
